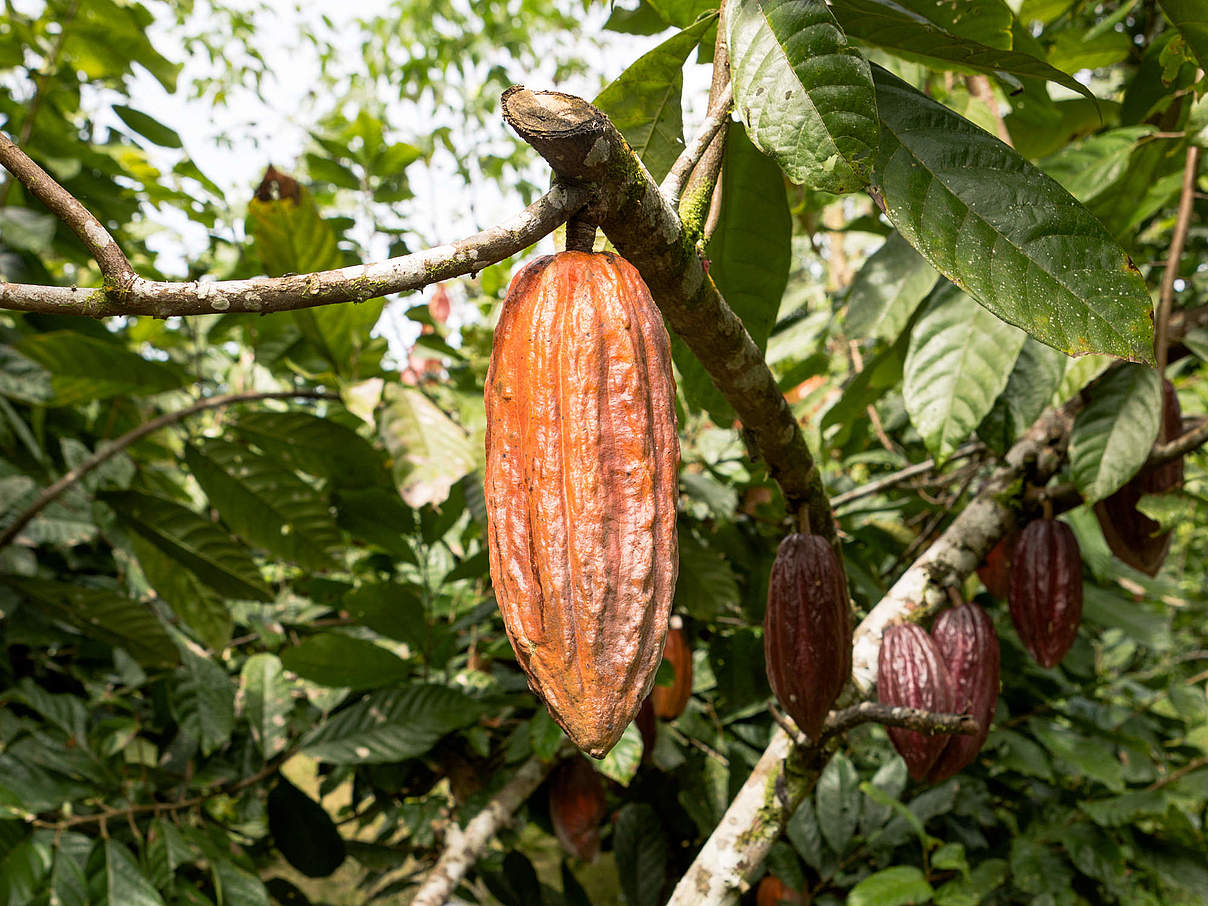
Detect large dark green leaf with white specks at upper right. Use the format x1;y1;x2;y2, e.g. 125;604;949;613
875;69;1154;361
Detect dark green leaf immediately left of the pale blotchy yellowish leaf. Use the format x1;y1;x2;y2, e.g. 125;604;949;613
233;410;385;488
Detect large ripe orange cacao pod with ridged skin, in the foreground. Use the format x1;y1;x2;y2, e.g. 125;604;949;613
486;251;679;759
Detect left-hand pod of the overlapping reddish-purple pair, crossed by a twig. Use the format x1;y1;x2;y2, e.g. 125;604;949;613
877;623;956;780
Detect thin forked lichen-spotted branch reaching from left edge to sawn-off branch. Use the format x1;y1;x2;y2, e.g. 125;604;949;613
0;134;591;318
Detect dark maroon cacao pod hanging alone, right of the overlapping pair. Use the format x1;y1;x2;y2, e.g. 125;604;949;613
1009;519;1082;667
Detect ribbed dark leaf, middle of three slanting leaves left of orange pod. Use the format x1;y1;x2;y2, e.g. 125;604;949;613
185;440;341;569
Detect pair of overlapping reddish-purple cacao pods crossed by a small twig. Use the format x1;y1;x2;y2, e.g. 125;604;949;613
877;604;999;783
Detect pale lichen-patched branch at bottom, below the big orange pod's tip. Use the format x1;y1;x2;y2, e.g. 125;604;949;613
411;756;553;906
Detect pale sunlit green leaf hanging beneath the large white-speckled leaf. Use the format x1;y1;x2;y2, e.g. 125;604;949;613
902;285;1027;463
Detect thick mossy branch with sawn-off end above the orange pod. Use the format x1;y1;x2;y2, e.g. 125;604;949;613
503;87;835;541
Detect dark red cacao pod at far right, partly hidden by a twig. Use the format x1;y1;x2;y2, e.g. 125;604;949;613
1094;381;1183;576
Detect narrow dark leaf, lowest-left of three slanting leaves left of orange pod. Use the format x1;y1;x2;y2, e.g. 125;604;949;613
105;490;273;600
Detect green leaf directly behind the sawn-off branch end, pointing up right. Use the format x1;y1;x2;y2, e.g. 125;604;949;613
593;19;713;182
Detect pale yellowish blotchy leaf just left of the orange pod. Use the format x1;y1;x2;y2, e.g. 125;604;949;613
378;384;478;507
